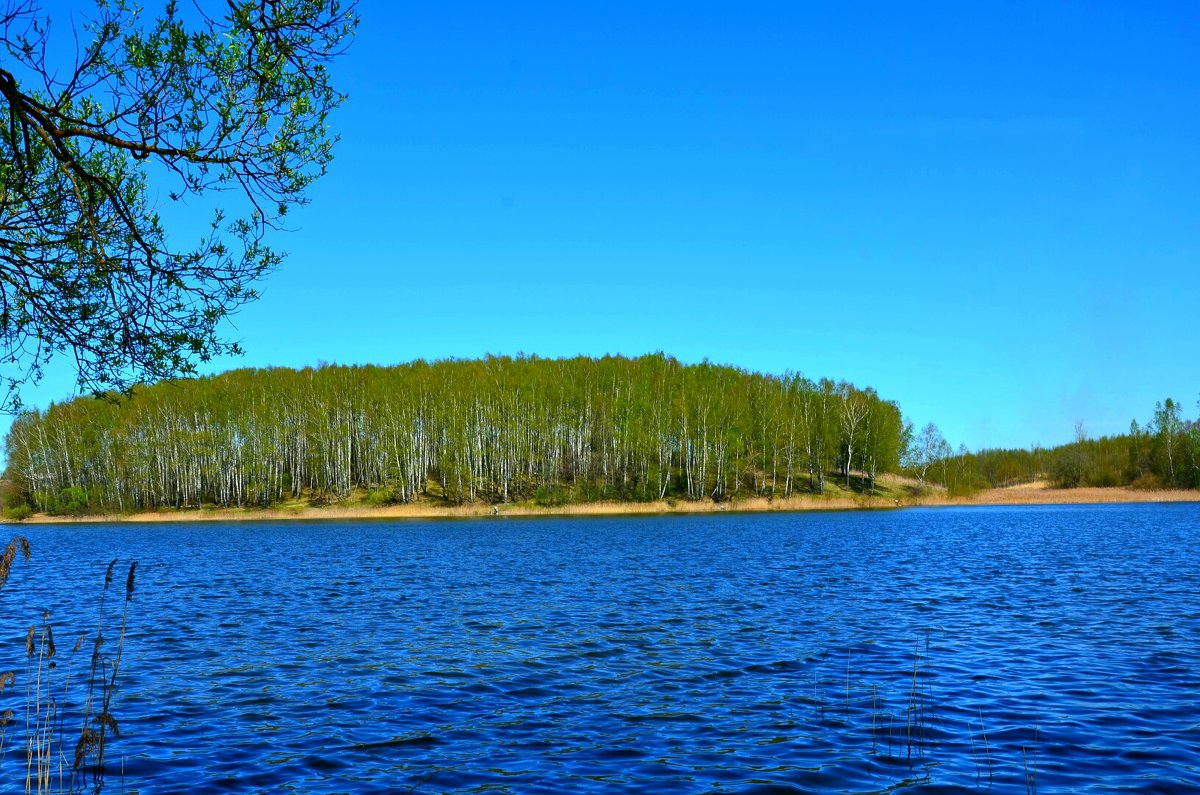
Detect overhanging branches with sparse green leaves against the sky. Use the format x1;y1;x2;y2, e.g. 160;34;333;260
0;0;358;408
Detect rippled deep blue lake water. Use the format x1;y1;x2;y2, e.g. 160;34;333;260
0;504;1200;793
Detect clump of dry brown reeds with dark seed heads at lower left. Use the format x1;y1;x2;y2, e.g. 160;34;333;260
0;537;138;795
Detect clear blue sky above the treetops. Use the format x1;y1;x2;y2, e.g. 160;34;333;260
5;0;1200;449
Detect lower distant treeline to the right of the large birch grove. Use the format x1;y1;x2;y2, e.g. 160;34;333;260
906;398;1200;494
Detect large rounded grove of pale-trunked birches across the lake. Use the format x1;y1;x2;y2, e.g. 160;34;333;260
7;354;907;513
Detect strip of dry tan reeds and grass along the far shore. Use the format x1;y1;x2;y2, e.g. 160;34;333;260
11;484;1200;525
